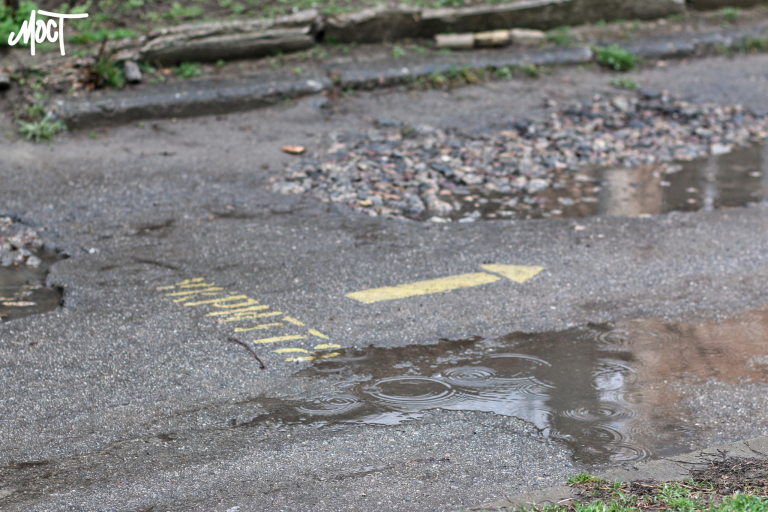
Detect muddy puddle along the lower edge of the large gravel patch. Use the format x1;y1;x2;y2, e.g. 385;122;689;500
450;146;768;222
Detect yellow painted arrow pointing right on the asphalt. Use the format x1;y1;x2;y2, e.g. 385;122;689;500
346;265;544;304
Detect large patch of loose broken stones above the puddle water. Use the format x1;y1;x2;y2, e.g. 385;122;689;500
272;91;768;220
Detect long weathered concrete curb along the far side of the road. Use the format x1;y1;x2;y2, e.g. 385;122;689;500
51;26;768;129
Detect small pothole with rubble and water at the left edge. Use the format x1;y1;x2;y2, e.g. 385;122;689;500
0;217;63;322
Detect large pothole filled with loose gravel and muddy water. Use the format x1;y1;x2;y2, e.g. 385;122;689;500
272;91;768;222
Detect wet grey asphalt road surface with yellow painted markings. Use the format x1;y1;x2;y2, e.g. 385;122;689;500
0;51;768;511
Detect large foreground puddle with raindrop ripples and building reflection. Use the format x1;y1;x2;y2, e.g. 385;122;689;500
252;309;768;463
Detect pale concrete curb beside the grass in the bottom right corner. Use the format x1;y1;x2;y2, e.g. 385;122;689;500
461;436;768;512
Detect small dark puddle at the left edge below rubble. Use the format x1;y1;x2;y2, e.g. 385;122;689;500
0;252;63;322
